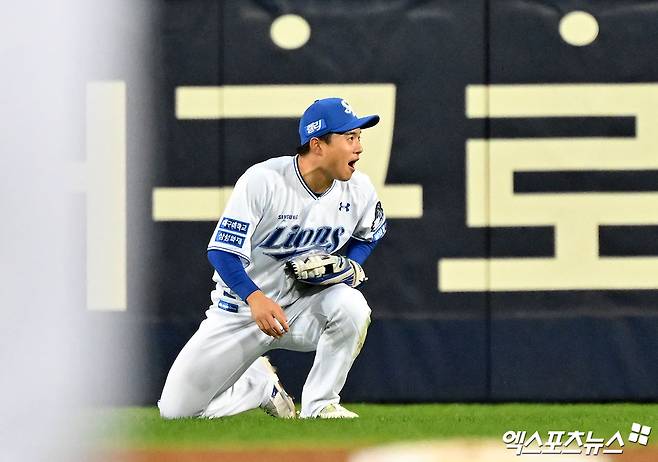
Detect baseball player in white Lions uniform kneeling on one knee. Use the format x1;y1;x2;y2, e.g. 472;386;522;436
158;98;386;418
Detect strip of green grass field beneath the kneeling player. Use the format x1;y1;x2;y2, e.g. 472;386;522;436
94;403;658;449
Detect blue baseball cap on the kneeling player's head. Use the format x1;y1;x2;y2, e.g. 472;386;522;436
299;98;379;146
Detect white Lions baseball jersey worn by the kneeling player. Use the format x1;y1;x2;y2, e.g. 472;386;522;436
208;156;386;312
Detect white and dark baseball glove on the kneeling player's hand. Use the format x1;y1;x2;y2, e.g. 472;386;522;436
286;254;368;288
